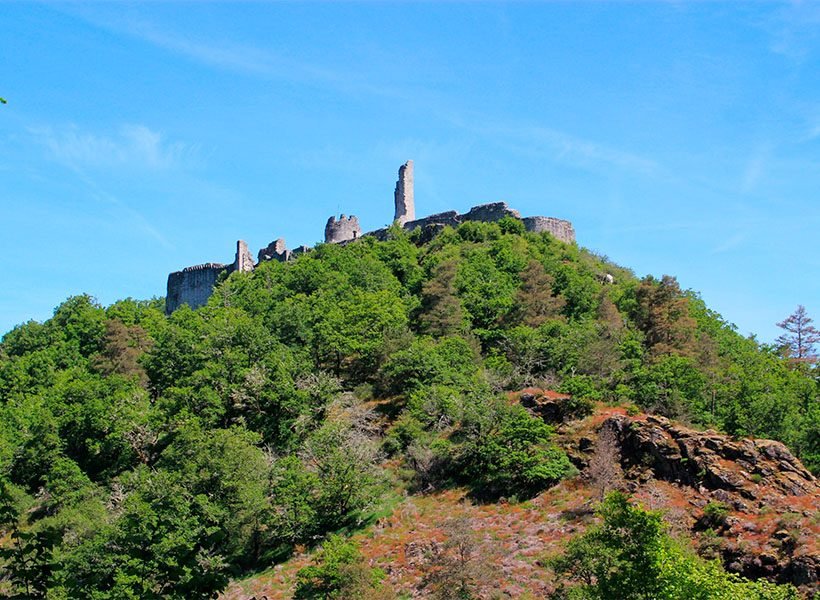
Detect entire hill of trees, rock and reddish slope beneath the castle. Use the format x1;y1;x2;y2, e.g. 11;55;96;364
0;215;820;599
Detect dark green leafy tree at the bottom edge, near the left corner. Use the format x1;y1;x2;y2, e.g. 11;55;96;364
63;469;228;600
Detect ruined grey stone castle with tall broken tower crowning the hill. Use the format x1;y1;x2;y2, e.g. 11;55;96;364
165;160;575;314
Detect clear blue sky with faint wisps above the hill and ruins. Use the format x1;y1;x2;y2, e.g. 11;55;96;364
0;2;820;341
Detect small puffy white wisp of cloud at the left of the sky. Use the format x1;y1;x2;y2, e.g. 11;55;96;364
29;124;198;170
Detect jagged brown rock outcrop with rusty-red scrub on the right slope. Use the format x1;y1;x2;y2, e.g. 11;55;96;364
588;415;820;597
